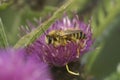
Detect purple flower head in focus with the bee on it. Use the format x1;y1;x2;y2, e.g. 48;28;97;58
27;16;92;66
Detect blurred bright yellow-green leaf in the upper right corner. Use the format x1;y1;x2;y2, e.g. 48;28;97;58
92;0;120;38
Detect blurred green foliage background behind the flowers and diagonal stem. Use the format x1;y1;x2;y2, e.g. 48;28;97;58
0;0;120;80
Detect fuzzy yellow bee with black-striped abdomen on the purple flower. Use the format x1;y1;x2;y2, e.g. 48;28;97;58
46;30;86;46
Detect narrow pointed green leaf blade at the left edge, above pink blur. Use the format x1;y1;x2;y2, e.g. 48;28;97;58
0;18;8;48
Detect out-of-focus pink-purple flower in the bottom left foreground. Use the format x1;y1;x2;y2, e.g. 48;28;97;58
0;49;51;80
